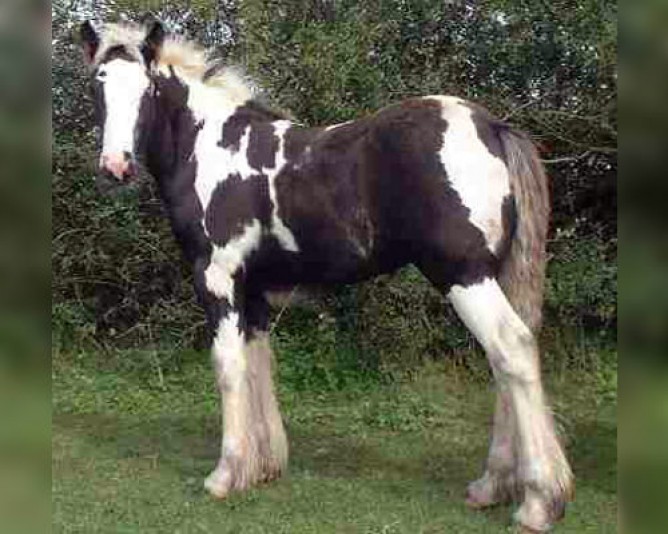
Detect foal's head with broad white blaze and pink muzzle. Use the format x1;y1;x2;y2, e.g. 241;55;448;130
80;22;165;182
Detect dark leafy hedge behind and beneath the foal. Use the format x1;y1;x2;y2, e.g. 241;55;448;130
52;0;617;389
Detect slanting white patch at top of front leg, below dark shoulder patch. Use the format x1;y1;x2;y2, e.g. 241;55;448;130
204;219;262;305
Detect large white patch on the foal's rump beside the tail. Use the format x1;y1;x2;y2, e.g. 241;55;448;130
426;96;510;253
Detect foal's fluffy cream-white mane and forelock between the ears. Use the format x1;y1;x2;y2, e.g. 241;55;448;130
95;23;257;107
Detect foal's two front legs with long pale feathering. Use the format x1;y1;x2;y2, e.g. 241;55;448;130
204;273;288;498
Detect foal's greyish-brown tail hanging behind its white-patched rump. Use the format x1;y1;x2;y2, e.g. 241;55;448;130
498;127;550;332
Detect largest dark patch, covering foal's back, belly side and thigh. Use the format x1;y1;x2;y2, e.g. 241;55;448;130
268;99;498;290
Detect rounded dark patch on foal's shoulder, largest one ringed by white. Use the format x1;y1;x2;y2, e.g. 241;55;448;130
205;174;271;245
